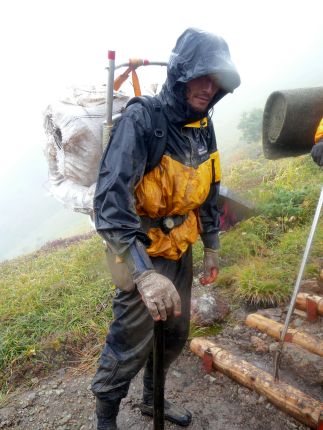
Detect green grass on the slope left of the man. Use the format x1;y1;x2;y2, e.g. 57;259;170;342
0;236;114;396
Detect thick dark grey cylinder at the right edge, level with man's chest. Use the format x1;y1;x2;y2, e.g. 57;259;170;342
263;87;323;160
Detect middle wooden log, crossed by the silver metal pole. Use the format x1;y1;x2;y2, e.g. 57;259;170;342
246;314;323;357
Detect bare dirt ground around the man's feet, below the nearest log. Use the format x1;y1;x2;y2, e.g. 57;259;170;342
0;351;314;430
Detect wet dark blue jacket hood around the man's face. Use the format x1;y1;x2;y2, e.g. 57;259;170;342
158;28;240;123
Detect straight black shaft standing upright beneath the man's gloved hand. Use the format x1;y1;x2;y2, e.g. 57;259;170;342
153;321;165;430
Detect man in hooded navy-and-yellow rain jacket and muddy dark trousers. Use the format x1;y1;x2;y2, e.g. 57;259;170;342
92;28;240;430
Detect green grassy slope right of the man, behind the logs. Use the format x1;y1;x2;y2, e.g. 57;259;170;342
217;156;323;306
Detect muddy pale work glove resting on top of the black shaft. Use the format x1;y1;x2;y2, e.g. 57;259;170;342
135;270;181;321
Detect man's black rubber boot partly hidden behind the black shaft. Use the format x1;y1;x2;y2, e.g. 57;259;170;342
139;363;192;427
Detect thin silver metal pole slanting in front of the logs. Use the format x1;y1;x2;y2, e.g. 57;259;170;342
274;187;323;380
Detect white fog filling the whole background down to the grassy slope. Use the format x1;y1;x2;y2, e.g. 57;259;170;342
0;0;323;258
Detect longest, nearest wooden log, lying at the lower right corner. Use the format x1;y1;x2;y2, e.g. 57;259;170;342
190;337;323;429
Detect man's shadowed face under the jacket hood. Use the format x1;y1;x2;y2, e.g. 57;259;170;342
186;75;220;112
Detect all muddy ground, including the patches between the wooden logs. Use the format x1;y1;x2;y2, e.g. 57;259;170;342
0;282;323;430
